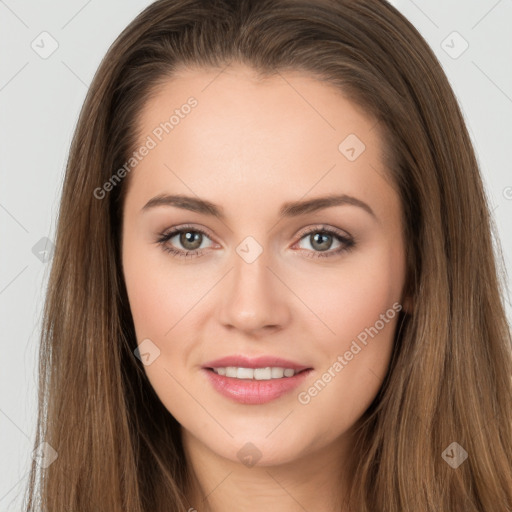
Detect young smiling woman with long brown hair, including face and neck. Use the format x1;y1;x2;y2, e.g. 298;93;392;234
26;0;512;512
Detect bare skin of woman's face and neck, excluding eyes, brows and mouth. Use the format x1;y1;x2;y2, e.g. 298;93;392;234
122;65;407;512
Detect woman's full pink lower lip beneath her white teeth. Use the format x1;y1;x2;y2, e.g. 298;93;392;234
203;368;312;405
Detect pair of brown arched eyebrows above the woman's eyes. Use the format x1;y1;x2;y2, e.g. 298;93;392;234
141;194;377;221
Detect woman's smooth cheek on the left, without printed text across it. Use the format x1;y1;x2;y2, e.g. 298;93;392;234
123;235;211;396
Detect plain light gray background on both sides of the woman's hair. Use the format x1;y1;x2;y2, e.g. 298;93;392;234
0;0;512;512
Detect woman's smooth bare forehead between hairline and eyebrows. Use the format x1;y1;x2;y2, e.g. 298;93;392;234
125;66;396;217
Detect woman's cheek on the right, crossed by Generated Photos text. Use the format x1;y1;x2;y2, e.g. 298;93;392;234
292;244;404;416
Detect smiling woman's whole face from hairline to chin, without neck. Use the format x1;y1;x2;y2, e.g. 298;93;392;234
122;66;405;465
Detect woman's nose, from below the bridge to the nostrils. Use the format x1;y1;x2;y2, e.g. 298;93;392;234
218;247;293;336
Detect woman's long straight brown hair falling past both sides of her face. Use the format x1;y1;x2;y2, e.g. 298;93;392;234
26;0;512;512
